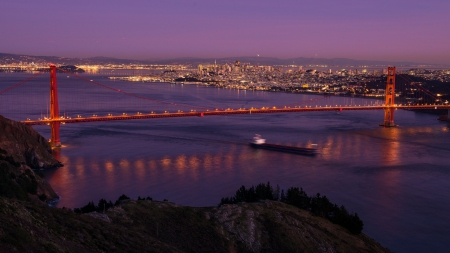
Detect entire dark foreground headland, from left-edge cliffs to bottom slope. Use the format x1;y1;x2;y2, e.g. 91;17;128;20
0;115;389;252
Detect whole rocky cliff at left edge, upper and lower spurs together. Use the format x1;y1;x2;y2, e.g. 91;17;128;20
0;116;61;202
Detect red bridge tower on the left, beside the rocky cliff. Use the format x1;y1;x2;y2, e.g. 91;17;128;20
50;64;61;147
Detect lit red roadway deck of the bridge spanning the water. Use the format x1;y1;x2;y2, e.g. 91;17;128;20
21;105;450;125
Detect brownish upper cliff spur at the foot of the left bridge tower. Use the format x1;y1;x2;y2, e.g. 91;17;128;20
0;116;62;169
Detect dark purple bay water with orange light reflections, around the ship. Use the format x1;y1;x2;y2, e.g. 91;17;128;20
0;71;450;252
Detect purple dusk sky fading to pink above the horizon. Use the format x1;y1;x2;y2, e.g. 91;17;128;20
0;0;450;64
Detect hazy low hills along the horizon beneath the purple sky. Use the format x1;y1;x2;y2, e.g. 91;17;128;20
0;53;440;67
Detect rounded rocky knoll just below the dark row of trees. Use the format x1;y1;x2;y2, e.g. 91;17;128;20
207;200;390;252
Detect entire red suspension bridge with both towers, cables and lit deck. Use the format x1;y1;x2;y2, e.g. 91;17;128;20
0;65;450;147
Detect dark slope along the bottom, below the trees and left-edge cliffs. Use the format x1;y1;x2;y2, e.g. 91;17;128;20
0;198;389;252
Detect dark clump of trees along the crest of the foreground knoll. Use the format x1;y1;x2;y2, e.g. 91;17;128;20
220;182;364;234
